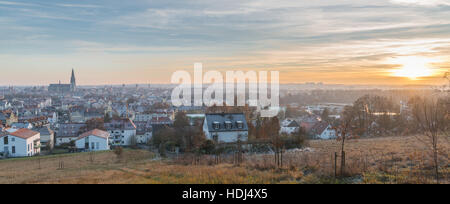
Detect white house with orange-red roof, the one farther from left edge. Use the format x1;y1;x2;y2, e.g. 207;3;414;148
75;129;110;151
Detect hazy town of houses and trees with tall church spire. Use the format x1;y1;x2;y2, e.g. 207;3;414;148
0;70;449;184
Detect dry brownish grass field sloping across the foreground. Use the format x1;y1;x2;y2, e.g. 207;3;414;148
0;137;450;184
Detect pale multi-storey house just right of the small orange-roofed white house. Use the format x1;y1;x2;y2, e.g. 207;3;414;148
105;118;137;146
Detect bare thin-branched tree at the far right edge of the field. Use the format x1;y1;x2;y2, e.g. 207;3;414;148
412;97;450;183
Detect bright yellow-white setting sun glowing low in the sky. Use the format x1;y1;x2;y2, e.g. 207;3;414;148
392;56;436;80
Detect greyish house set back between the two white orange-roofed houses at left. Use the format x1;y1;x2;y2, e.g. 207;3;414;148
55;123;86;146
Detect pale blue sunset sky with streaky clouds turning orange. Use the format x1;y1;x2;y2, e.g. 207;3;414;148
0;0;450;86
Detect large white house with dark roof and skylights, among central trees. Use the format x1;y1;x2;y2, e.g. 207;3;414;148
203;113;248;143
